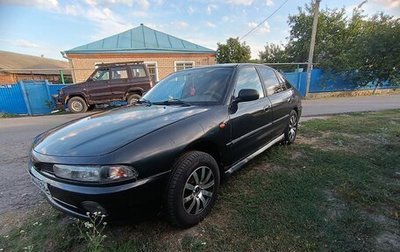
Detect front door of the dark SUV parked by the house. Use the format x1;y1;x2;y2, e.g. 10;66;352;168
86;68;111;103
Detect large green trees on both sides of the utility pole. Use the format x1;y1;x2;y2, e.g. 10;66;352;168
260;4;400;86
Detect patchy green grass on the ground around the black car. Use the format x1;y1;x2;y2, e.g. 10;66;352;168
0;110;400;251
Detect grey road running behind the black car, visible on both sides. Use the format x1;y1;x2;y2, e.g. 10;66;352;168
0;95;400;228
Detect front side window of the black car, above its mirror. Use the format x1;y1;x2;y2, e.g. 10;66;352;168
234;67;264;98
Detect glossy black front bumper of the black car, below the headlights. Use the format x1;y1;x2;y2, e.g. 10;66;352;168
29;165;169;219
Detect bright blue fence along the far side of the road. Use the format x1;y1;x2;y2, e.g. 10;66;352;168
0;69;396;115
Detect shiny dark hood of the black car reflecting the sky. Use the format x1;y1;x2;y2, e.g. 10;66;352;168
33;105;208;157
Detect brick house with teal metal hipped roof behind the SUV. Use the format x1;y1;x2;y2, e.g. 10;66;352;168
61;24;215;83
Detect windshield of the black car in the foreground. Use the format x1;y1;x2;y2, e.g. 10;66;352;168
143;67;233;105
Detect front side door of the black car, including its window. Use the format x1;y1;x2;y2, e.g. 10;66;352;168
228;66;272;164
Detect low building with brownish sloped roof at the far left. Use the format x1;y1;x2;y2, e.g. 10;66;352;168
0;51;71;84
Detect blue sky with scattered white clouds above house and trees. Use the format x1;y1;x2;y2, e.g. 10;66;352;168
0;0;400;59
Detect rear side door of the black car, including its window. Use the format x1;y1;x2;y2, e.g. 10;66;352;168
257;66;295;137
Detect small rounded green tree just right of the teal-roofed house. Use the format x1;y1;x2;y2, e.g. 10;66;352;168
216;38;251;63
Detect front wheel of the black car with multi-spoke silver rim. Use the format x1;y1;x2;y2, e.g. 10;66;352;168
166;151;220;227
